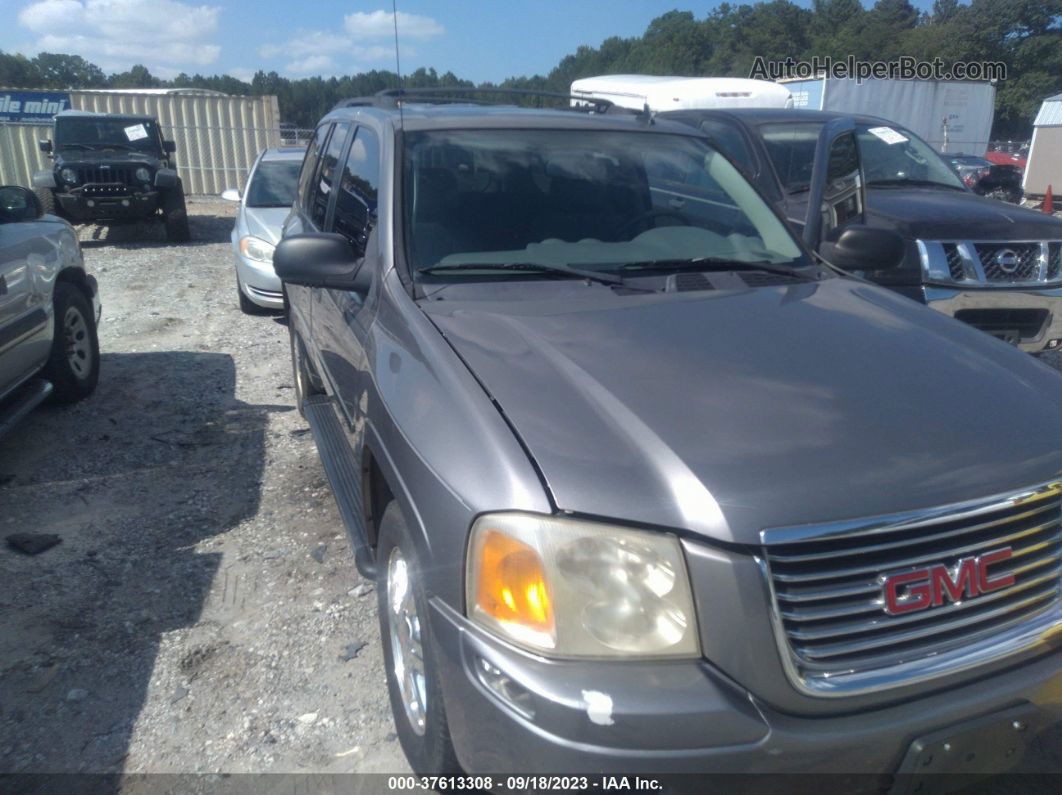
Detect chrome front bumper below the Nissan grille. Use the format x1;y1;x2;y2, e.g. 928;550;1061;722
921;286;1062;353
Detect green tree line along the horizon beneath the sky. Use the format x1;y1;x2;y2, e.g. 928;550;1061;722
0;0;1062;138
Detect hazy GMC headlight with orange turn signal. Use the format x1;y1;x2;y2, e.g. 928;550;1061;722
465;513;700;657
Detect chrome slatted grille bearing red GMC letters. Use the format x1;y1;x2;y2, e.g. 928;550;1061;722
763;483;1062;696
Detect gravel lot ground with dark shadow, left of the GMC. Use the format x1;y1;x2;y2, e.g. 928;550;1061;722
0;195;1062;774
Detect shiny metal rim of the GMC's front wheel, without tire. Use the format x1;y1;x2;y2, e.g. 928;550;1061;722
388;547;428;736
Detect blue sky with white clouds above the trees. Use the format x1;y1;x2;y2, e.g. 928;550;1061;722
0;0;931;82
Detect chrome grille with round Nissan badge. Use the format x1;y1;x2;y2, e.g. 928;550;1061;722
918;240;1062;287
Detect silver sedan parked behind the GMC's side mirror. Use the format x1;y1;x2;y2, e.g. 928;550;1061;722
221;148;306;314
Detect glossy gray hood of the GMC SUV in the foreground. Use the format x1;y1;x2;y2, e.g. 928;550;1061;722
423;278;1062;545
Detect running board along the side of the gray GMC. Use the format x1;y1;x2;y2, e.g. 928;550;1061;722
303;395;376;580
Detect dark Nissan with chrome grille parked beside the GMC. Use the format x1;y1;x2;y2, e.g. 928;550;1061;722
661;108;1062;352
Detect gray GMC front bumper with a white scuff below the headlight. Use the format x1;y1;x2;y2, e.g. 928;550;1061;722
431;600;1062;775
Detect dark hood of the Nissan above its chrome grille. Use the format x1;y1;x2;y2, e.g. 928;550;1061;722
867;188;1062;241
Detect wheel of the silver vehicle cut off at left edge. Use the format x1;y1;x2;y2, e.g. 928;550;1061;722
42;281;100;403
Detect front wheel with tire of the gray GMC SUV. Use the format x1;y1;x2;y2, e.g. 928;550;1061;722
376;502;461;776
